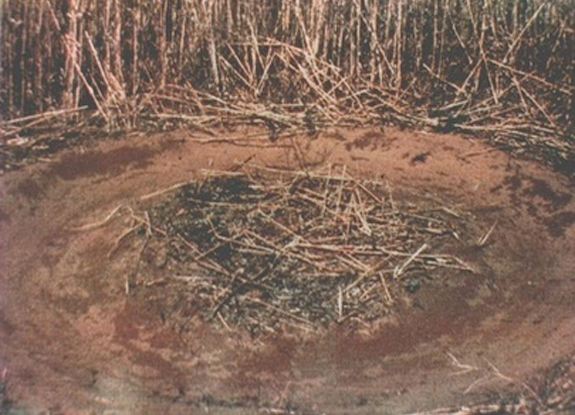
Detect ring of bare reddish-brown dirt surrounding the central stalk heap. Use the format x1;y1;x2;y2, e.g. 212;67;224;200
0;129;575;414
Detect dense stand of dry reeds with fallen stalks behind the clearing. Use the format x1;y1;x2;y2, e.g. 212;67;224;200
0;0;575;164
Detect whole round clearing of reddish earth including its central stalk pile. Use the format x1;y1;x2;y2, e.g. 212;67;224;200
0;129;575;414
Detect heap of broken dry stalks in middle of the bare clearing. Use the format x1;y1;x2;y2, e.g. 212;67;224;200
129;168;474;335
